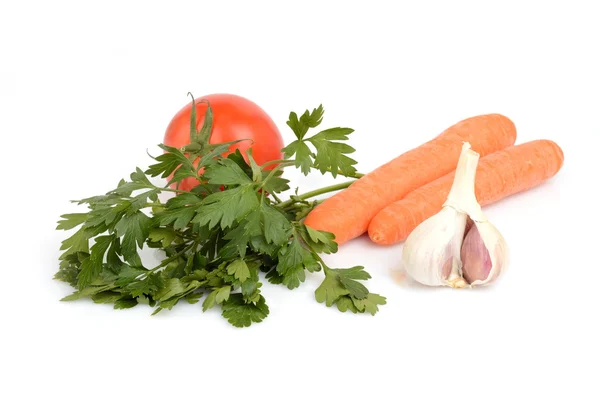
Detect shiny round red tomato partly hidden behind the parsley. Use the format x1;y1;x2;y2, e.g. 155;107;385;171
163;94;283;191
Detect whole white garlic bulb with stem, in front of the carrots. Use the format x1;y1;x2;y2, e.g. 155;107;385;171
402;142;508;288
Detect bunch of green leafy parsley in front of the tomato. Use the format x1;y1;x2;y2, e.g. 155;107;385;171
55;95;385;327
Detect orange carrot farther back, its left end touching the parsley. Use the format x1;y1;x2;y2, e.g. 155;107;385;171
305;114;516;244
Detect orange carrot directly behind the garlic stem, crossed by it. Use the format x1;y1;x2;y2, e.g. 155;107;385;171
369;140;564;245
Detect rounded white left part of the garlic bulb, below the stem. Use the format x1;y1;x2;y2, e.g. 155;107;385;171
402;207;467;287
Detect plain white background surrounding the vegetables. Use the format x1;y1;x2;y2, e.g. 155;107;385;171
0;0;600;398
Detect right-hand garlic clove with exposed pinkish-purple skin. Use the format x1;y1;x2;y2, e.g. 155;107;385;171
460;221;508;286
